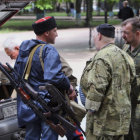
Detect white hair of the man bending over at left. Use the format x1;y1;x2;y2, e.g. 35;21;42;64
3;37;22;50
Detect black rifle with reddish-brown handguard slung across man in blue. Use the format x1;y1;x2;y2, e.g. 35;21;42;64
0;63;76;137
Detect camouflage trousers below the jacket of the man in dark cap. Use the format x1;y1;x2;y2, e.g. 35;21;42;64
86;133;124;140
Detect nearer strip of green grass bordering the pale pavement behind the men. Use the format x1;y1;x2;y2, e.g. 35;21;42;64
0;16;121;33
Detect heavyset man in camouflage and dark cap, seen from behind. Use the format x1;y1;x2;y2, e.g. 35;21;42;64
80;24;135;140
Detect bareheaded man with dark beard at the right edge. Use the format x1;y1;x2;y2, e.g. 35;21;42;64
122;17;140;140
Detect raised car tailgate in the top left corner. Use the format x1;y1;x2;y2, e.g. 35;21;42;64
0;0;35;26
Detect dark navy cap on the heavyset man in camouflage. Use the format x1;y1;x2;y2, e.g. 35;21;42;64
96;23;115;38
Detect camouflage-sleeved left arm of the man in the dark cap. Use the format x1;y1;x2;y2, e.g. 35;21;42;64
85;59;111;111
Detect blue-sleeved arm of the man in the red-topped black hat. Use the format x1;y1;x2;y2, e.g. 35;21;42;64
43;49;70;90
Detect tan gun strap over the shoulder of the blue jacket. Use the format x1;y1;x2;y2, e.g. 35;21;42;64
24;44;45;80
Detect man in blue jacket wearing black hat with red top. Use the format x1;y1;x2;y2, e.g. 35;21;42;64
15;17;75;140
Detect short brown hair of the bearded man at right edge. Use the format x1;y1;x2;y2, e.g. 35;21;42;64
121;17;140;32
